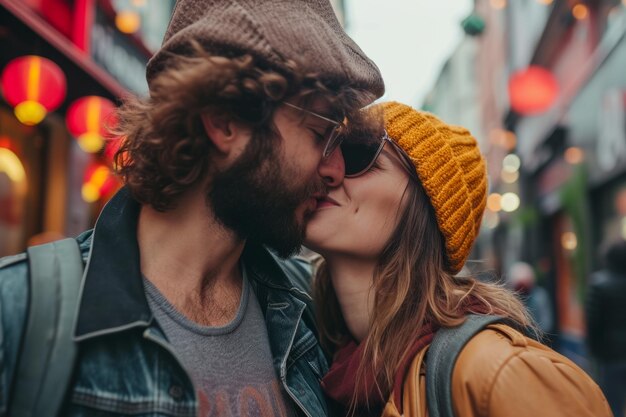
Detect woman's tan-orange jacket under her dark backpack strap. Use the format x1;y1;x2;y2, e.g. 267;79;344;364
383;324;612;417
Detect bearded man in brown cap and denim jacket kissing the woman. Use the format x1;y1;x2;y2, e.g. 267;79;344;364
0;0;383;417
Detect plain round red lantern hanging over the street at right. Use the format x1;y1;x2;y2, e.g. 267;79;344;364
509;66;559;115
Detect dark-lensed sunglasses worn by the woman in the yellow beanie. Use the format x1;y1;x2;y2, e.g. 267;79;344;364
341;132;415;178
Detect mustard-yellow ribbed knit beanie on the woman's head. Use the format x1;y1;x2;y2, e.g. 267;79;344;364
381;102;487;273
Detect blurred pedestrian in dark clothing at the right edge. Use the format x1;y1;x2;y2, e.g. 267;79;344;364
586;240;626;417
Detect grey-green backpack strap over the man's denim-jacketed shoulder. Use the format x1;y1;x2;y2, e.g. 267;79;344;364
9;239;83;417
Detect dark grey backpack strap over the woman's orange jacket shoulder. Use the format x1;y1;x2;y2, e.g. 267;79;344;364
426;314;504;417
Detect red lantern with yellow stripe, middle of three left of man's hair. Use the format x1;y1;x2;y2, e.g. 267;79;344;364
65;96;115;153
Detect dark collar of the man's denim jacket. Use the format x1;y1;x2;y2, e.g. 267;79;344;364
74;187;307;341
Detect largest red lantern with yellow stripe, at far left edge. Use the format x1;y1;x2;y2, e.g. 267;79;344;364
2;55;66;126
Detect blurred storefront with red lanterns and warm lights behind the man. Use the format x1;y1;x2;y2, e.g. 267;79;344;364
0;0;174;256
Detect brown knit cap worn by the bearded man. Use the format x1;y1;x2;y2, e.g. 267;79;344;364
146;0;385;99
